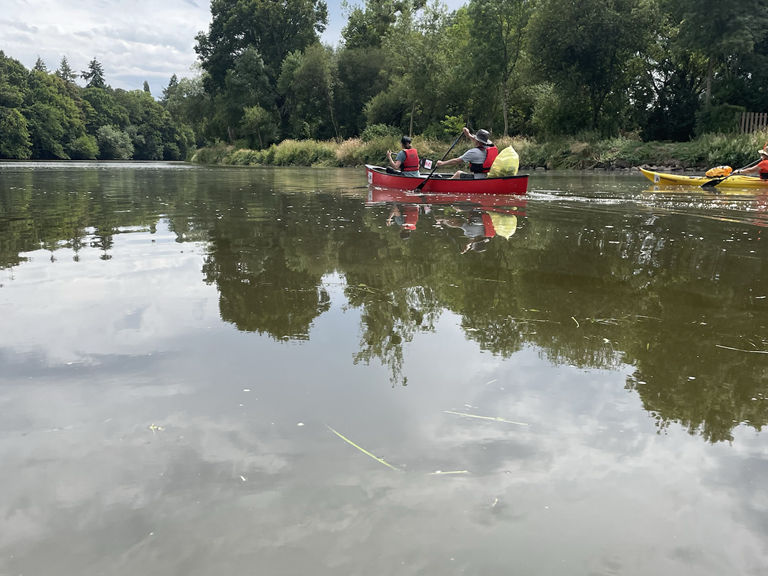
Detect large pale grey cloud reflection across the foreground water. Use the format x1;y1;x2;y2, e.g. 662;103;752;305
0;336;765;575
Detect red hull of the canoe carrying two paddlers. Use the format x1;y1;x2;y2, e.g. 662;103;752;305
365;164;528;195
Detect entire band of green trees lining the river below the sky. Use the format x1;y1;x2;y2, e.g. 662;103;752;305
0;0;768;159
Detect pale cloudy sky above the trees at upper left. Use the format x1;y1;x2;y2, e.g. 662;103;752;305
0;0;462;95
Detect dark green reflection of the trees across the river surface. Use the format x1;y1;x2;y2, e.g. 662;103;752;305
0;172;768;442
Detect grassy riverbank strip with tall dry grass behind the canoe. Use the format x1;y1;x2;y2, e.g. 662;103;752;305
192;133;768;170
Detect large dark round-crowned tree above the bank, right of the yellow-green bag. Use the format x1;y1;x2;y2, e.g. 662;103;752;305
528;0;656;129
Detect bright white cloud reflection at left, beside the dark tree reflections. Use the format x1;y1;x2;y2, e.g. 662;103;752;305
0;225;219;362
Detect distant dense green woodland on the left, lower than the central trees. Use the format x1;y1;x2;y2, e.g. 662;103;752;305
0;51;195;160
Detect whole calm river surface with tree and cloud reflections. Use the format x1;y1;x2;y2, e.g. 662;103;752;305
0;163;768;576
